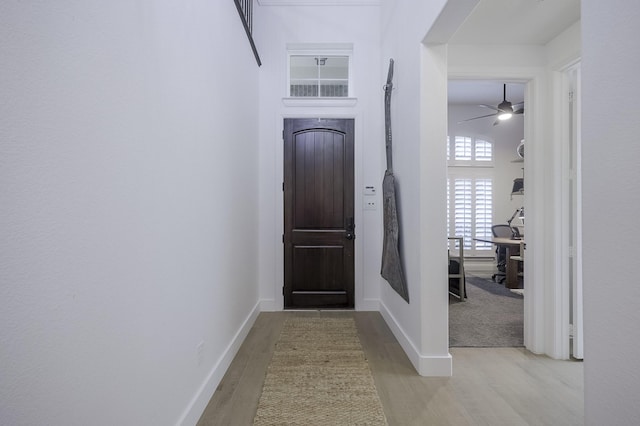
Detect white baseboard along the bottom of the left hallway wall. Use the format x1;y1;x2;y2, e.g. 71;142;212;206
177;302;260;426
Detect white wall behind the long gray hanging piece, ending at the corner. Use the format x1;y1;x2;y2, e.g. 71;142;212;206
381;0;451;375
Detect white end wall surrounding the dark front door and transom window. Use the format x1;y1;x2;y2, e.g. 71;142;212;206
254;2;386;310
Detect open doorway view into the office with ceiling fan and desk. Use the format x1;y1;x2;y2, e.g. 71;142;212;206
447;80;526;347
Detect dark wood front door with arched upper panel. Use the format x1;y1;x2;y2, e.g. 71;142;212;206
284;118;355;309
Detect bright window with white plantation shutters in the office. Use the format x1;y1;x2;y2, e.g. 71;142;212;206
447;136;493;256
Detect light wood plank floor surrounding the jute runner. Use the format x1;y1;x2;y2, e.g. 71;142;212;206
198;311;584;426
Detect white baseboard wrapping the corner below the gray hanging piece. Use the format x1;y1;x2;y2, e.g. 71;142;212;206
380;301;453;377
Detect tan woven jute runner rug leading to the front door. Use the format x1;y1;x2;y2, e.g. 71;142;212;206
254;317;387;425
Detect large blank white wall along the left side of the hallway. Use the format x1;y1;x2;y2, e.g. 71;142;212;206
0;0;258;425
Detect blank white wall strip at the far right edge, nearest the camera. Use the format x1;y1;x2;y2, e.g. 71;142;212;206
582;0;640;426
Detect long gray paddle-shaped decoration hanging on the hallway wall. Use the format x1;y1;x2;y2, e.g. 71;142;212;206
380;59;409;303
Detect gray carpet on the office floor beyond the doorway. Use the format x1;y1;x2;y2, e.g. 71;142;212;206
449;276;524;347
